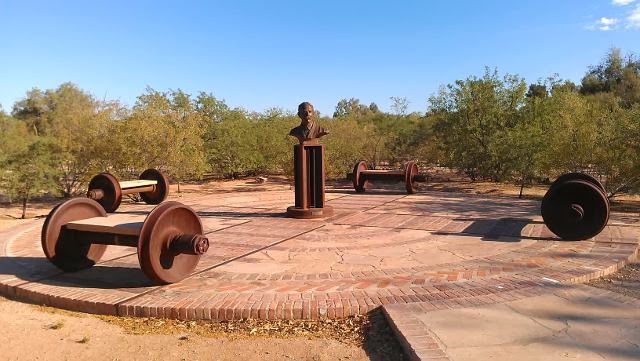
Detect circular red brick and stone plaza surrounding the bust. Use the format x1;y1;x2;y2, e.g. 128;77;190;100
0;187;640;360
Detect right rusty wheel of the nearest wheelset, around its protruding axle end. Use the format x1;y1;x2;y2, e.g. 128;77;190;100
138;202;203;284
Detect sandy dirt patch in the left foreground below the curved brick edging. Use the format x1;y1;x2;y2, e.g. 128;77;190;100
0;297;404;361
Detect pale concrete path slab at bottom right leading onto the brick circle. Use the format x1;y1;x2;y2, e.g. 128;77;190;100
385;285;640;361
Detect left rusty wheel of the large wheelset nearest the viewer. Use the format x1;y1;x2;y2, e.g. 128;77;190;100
40;198;107;272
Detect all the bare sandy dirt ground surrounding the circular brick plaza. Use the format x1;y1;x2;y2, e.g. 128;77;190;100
0;174;640;360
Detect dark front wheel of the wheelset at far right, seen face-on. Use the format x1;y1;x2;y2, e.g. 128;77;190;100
540;178;609;241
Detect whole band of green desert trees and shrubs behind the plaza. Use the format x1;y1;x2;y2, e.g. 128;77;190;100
0;48;640;217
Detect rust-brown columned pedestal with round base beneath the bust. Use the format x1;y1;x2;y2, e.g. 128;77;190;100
287;142;333;218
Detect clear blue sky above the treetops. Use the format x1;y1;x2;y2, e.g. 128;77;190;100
0;0;640;115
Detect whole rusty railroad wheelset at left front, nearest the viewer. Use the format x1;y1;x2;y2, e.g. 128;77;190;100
41;198;209;283
